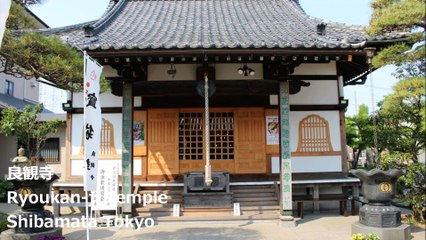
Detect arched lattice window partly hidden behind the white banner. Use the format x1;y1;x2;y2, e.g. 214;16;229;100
80;118;117;156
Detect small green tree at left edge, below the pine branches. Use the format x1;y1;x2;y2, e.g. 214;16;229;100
0;104;61;160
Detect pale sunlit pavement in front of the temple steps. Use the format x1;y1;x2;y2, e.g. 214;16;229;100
0;204;425;240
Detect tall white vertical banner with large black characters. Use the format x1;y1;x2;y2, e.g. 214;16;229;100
83;52;102;191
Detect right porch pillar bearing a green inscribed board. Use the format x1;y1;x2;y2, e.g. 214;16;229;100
278;80;293;218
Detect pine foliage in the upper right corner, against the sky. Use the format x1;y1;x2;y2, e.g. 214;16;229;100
368;0;426;79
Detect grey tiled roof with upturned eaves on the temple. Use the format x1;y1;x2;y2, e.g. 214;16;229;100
42;0;410;50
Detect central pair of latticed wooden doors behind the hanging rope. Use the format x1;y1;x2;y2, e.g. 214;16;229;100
178;109;235;173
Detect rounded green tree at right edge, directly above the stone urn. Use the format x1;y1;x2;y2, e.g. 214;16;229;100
377;77;426;163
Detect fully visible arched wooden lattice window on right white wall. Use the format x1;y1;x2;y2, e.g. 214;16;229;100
296;114;336;155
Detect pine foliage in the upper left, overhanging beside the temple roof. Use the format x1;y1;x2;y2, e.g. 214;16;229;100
0;1;109;91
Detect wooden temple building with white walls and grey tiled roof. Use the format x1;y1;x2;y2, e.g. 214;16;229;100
44;0;405;221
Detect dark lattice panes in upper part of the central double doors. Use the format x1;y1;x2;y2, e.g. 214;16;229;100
179;112;234;160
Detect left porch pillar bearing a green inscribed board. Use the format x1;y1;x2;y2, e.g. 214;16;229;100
121;82;134;216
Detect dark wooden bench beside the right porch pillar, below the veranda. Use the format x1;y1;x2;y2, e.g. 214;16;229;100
293;194;348;218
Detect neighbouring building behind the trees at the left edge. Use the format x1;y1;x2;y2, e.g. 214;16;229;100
0;6;67;177
